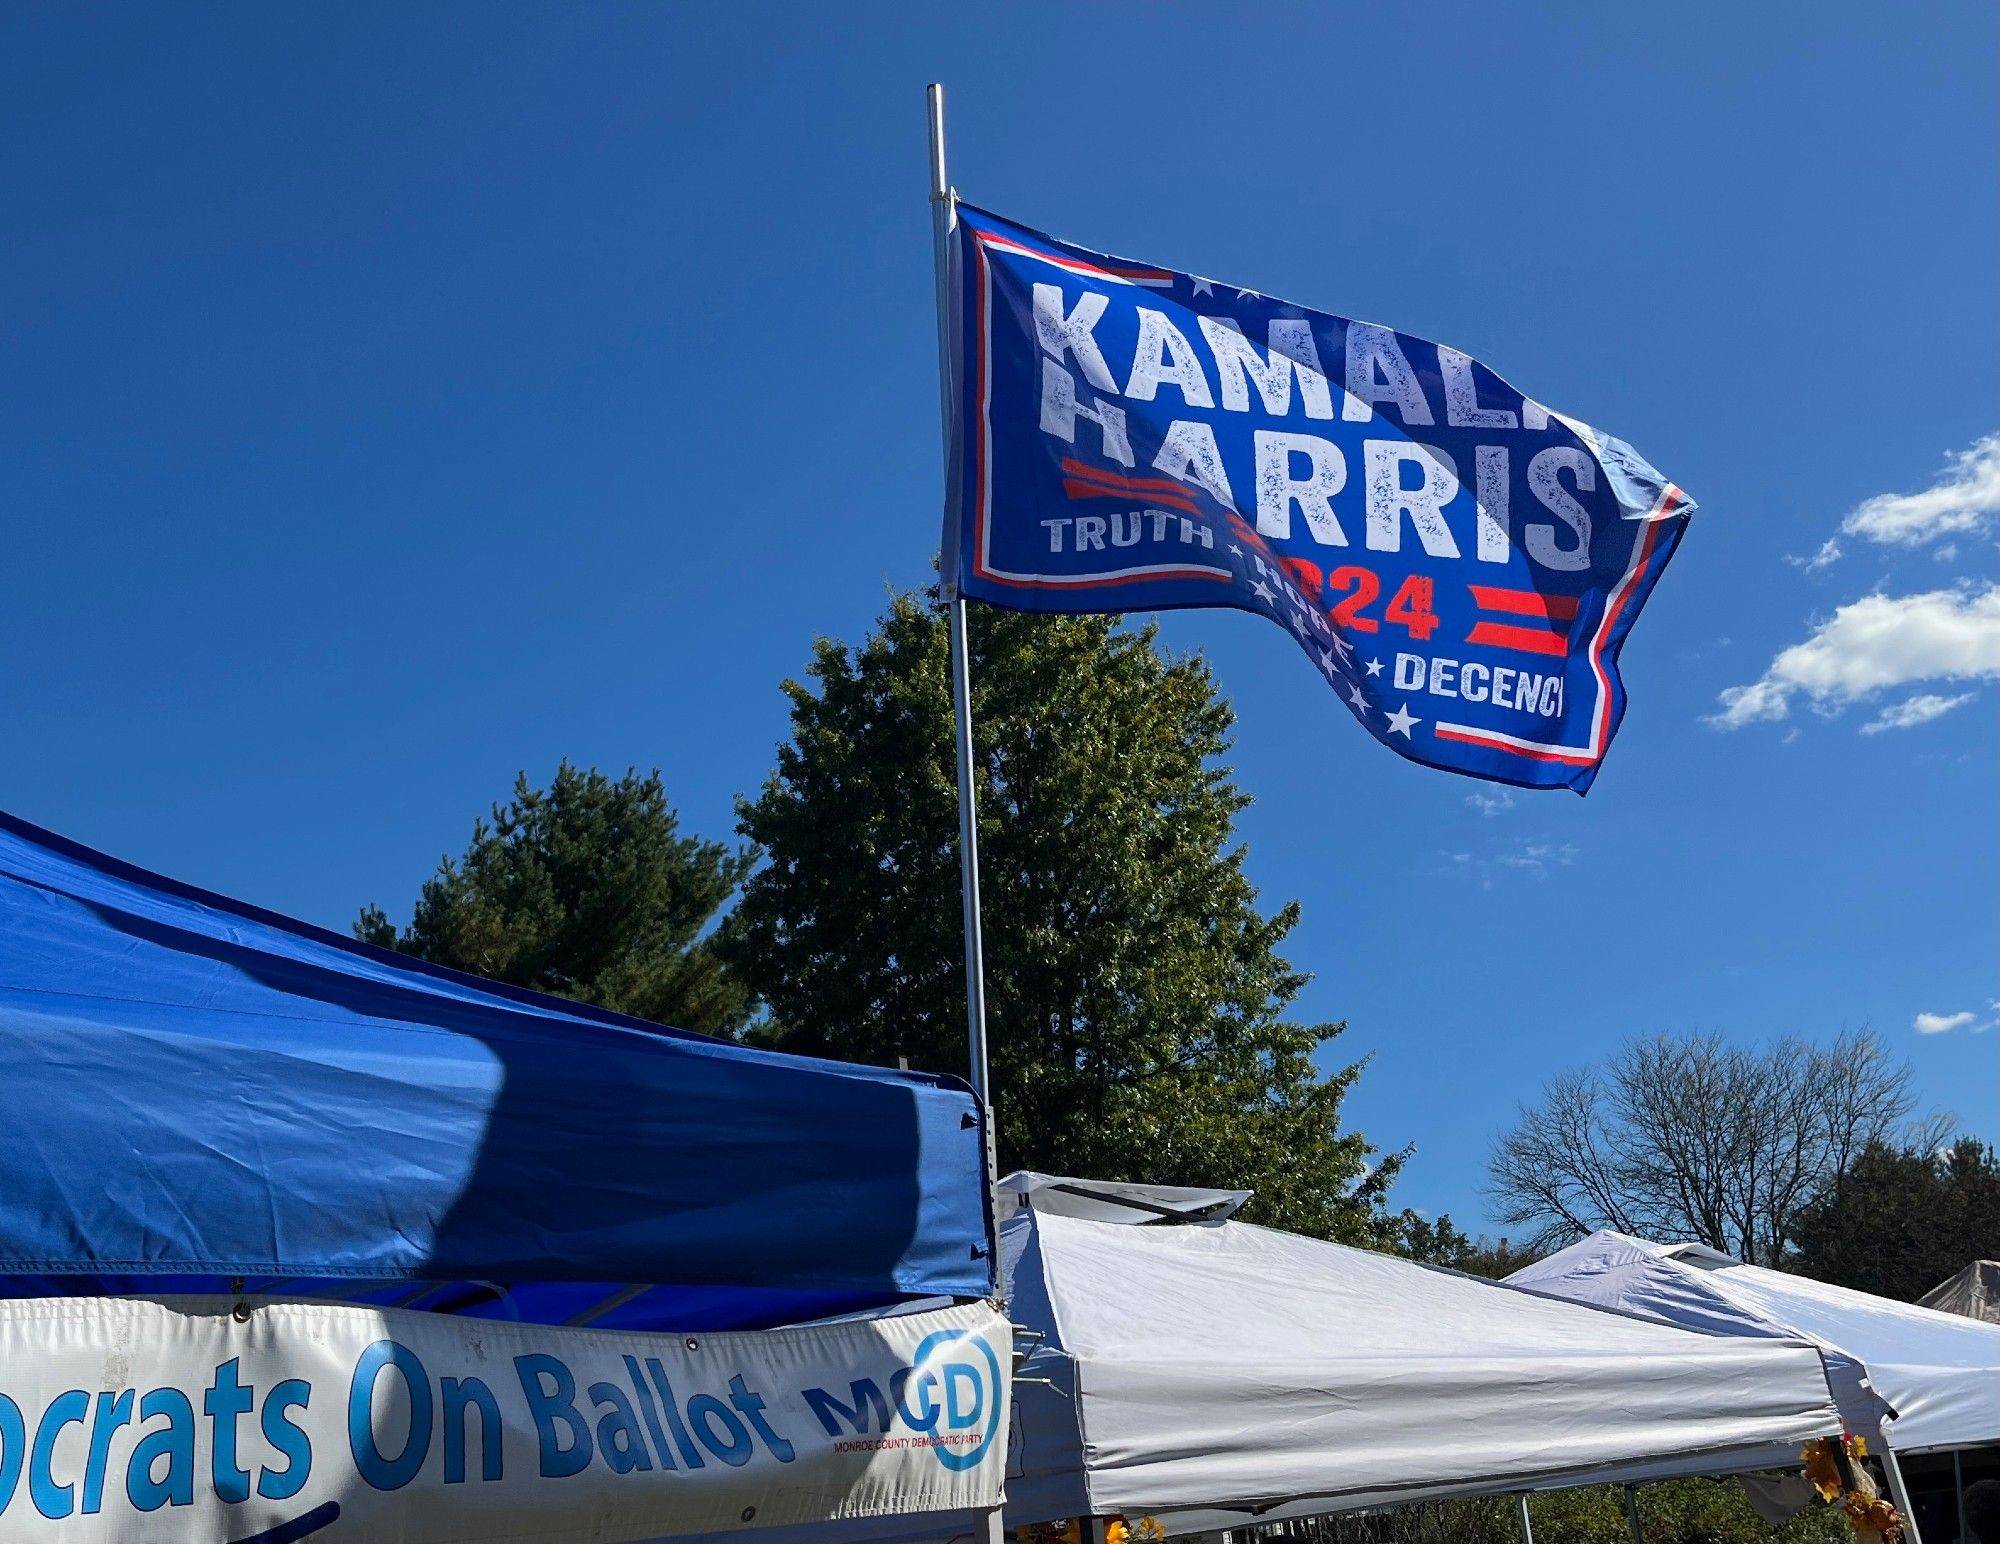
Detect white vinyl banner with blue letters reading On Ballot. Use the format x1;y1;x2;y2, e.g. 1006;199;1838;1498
0;1298;1010;1544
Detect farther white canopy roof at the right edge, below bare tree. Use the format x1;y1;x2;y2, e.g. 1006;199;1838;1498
1508;1232;2000;1452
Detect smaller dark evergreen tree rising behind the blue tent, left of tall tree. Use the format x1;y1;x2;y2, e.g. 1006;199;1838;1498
354;762;752;1034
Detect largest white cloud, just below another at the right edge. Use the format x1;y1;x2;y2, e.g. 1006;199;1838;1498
1708;584;2000;730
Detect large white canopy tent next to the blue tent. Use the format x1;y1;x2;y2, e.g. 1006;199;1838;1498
676;1176;1840;1544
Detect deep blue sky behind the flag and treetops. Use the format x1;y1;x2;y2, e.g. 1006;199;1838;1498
0;2;2000;1226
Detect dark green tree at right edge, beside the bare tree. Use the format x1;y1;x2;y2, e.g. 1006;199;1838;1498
1796;1136;2000;1302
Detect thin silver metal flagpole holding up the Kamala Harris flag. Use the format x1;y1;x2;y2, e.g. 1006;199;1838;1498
924;84;998;1184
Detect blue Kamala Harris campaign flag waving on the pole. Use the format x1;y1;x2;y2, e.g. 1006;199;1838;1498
944;204;1694;792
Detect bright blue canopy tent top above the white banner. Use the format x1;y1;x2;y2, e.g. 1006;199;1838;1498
0;814;992;1328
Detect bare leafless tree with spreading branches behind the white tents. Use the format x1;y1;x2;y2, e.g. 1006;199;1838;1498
1488;1032;1912;1266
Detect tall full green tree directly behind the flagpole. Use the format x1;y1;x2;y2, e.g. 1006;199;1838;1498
722;594;1404;1242
